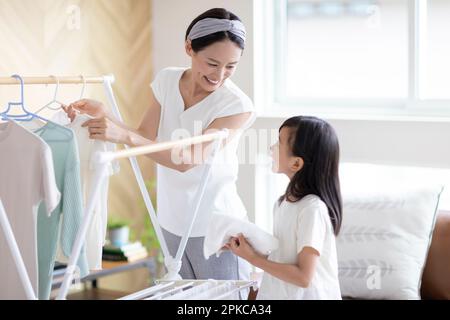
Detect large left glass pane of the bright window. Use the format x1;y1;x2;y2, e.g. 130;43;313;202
281;0;408;100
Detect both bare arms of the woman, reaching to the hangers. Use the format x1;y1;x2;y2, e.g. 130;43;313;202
70;91;251;172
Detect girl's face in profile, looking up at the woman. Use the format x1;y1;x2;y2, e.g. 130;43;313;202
270;127;303;178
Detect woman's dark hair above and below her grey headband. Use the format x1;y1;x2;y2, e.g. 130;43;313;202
184;8;245;52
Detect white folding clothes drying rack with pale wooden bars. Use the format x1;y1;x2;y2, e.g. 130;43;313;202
0;75;256;300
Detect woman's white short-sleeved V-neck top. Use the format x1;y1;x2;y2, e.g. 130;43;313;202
151;67;255;237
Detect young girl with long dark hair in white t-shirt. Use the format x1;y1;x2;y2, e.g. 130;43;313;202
227;116;342;300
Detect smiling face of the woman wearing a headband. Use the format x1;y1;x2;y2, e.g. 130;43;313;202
186;39;242;92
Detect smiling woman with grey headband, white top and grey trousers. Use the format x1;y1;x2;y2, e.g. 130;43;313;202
66;8;255;280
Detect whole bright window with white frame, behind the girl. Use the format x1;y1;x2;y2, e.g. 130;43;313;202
255;0;450;116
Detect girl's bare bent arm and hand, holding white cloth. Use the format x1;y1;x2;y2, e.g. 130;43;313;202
229;235;319;288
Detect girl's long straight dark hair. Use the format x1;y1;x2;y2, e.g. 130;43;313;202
280;116;342;235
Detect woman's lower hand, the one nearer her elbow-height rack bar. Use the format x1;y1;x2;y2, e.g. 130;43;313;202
82;117;127;143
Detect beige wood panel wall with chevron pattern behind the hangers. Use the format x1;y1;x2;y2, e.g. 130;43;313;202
0;0;157;290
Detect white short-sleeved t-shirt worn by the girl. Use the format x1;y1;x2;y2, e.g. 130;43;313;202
257;195;342;300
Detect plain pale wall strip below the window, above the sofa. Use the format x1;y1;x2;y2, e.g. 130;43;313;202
254;117;450;169
